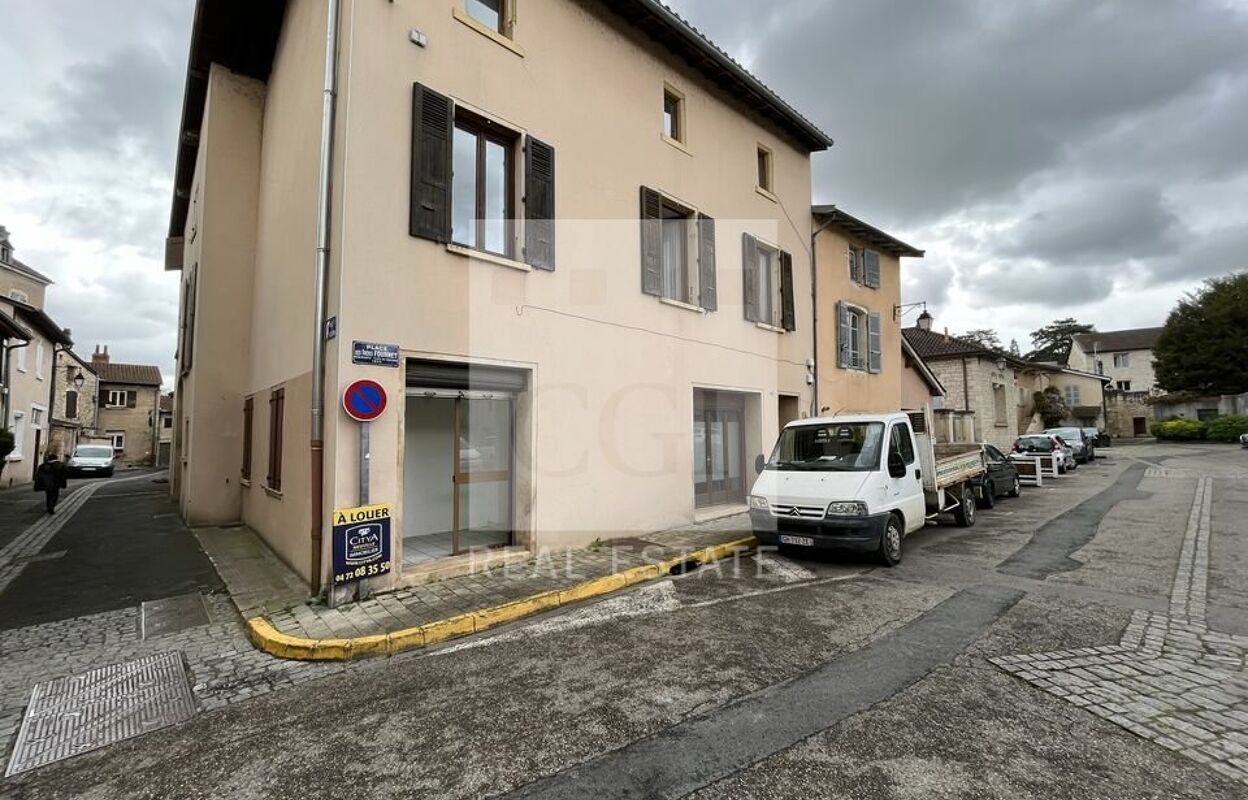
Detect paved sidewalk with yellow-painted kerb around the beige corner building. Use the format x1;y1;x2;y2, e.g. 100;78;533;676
200;514;751;639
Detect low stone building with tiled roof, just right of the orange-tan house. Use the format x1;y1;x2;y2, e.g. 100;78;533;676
902;313;1027;449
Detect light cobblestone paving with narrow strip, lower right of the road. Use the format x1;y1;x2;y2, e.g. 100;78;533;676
992;469;1248;784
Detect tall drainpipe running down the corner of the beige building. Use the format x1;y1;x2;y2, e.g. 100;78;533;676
310;0;341;597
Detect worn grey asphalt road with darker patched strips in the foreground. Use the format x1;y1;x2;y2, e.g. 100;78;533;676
0;446;1248;800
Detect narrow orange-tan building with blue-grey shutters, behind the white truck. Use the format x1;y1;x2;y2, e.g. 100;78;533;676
812;206;924;414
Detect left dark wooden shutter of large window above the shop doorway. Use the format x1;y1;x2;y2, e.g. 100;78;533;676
408;84;454;242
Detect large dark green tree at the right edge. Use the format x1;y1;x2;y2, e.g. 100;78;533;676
1153;272;1248;394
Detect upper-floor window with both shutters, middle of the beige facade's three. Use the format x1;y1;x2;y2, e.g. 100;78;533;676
640;186;718;311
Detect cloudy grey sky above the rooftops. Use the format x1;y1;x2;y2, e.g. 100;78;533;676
0;0;1248;377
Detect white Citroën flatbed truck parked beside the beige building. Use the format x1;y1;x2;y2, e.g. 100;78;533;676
750;412;983;565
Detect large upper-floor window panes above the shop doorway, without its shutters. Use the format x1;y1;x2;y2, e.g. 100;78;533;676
451;111;515;257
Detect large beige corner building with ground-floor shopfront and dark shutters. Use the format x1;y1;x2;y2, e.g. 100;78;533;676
168;0;828;589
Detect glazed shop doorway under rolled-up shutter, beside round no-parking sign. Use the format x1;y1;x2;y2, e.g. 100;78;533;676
403;391;515;567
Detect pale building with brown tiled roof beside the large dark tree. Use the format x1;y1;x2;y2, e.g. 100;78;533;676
1066;328;1163;439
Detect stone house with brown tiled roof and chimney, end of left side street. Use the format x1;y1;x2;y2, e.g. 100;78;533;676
91;346;161;466
